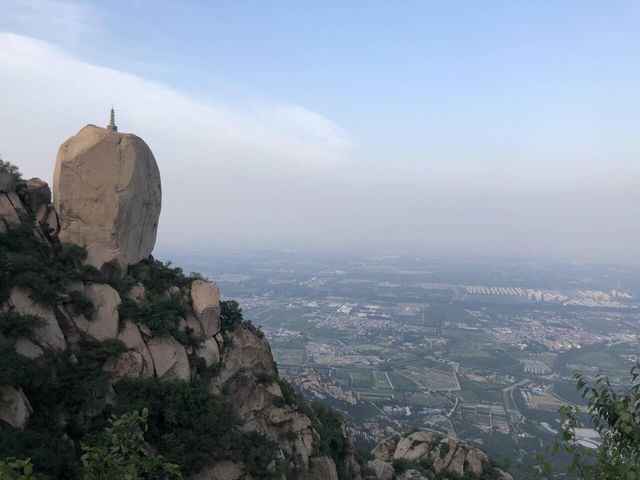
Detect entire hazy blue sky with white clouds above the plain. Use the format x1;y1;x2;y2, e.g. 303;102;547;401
0;0;640;260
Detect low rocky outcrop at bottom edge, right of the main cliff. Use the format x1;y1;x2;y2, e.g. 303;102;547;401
369;430;511;480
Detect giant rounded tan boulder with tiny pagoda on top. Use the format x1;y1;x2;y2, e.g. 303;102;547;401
53;125;161;276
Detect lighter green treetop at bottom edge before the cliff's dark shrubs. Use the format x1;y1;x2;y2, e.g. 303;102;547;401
82;408;182;480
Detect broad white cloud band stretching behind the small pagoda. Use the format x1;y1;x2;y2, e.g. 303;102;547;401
0;33;349;174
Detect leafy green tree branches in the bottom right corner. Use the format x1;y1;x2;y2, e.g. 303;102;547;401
541;362;640;480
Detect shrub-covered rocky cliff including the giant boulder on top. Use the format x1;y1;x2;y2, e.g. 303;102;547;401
0;126;360;480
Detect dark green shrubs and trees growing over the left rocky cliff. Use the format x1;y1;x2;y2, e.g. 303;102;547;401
0;217;348;480
